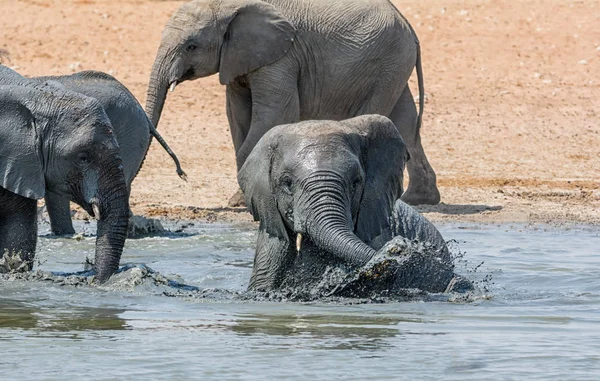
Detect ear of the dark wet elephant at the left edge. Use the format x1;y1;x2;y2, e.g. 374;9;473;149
0;87;45;200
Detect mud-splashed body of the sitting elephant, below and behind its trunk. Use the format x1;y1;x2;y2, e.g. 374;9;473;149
278;200;460;297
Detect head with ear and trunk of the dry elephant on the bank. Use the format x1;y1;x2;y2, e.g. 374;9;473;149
146;0;295;126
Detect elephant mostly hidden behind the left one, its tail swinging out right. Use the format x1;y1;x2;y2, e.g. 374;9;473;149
0;66;185;235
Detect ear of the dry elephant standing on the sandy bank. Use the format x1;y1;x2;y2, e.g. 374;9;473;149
219;1;296;85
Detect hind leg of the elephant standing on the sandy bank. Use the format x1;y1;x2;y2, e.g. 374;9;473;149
389;85;440;205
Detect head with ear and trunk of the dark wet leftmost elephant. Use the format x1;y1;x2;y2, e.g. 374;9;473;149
0;85;129;282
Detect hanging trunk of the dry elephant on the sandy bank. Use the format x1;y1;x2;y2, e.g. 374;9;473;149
146;46;172;128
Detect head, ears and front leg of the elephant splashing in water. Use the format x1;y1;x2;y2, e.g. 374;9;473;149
238;115;408;289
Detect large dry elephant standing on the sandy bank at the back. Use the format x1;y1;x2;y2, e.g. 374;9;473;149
146;0;440;206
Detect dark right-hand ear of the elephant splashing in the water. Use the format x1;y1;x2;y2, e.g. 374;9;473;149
347;115;408;243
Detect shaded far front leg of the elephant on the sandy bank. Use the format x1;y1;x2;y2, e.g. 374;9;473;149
226;81;252;208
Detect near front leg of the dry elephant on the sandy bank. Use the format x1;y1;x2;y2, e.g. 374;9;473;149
236;68;300;171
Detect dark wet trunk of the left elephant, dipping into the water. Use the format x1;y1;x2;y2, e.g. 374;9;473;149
92;160;129;283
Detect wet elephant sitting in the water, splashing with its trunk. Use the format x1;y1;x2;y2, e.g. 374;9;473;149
238;115;468;295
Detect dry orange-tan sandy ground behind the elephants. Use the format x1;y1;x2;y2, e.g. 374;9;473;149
0;0;600;223
